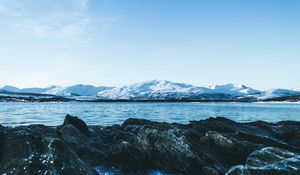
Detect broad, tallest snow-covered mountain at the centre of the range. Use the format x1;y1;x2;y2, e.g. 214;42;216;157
98;80;209;99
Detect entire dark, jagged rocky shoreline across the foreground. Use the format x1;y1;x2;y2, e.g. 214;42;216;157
0;115;300;175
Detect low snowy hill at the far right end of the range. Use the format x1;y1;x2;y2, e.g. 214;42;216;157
257;89;300;100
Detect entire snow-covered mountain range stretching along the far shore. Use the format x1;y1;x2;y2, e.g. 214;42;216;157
0;80;300;101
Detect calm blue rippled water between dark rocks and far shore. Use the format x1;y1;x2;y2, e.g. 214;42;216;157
0;102;300;126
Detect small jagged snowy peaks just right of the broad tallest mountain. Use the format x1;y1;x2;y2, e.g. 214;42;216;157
209;83;261;96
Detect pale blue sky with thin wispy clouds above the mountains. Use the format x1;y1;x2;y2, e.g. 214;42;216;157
0;0;300;89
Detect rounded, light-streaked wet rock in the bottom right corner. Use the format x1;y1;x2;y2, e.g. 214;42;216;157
227;147;300;175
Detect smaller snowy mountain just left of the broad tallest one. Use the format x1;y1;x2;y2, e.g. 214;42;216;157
44;84;111;96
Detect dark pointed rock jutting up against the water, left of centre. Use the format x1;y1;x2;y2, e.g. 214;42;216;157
63;114;91;137
